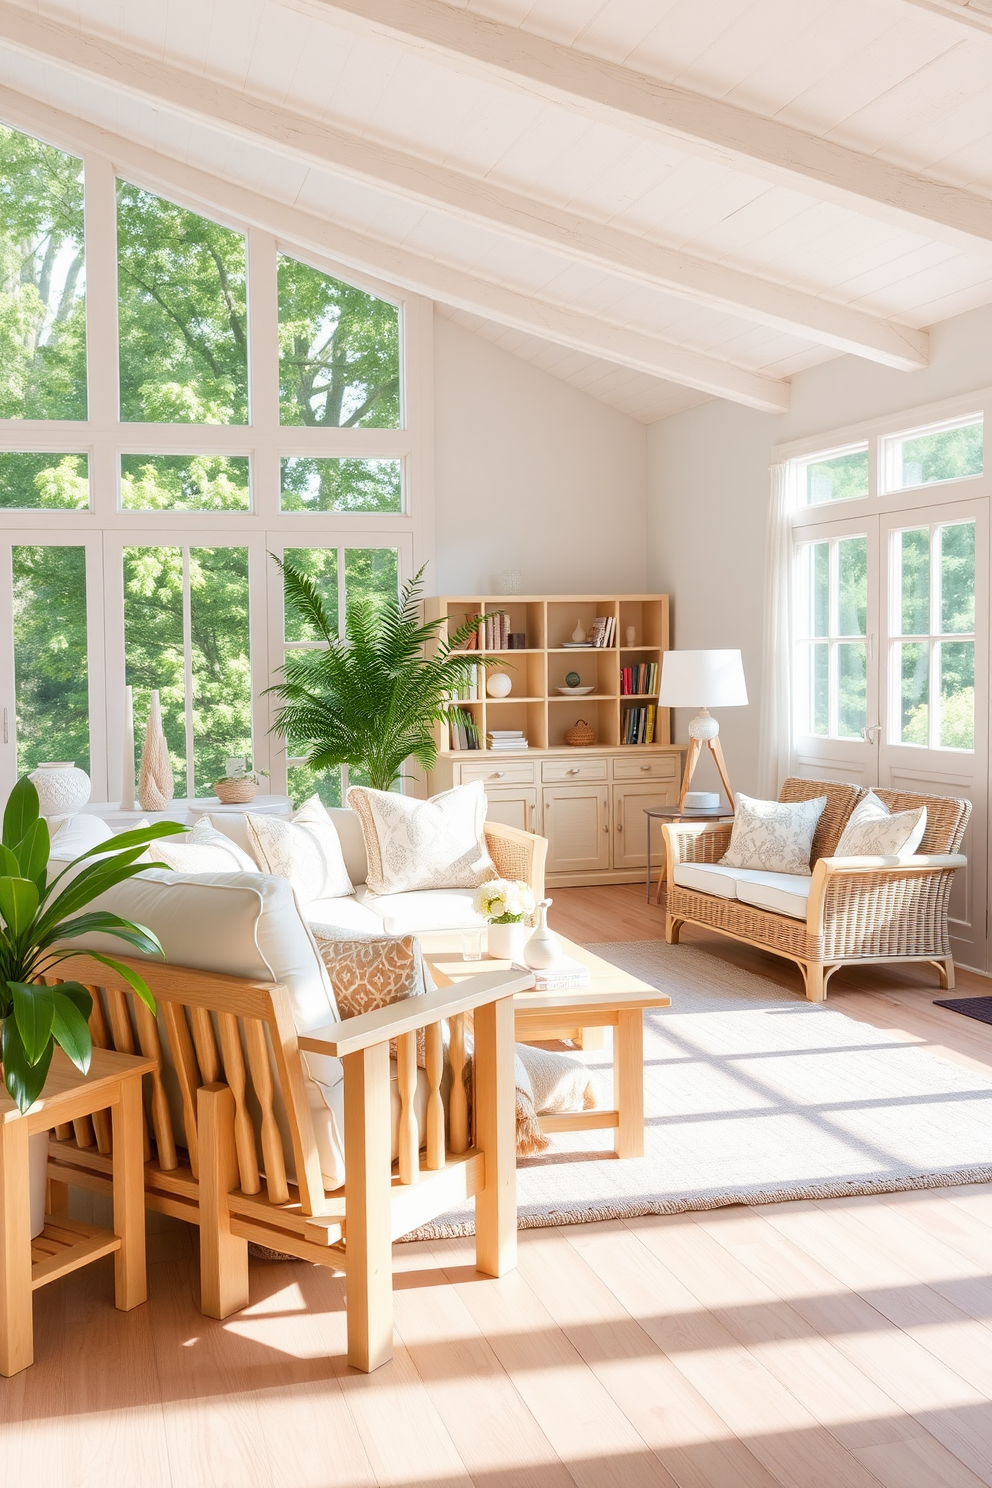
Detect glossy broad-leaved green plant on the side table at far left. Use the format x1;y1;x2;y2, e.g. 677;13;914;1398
0;777;186;1112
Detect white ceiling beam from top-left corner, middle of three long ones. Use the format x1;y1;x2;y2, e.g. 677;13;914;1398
0;3;928;371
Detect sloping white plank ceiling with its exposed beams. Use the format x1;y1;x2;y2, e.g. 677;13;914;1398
0;0;992;421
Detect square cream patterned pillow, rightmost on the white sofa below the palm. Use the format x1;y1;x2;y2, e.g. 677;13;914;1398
348;780;497;894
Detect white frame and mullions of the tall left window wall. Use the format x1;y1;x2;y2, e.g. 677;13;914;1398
0;113;434;801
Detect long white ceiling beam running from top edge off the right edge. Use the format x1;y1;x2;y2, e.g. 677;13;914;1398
297;0;992;254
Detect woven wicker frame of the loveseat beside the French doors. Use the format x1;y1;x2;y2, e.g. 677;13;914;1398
665;778;971;1001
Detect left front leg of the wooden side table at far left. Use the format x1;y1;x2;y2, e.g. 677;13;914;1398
0;1117;34;1376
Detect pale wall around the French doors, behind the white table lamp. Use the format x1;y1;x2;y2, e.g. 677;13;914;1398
647;294;992;792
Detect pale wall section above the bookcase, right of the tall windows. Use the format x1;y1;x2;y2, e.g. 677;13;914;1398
427;315;647;594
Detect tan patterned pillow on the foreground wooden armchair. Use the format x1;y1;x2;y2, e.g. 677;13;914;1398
311;926;427;1068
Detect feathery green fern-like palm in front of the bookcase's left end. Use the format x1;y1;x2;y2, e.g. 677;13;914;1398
271;558;498;790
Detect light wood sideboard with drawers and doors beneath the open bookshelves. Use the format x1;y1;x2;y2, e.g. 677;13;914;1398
425;744;683;888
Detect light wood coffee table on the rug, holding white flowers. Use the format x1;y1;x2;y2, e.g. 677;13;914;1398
418;931;671;1158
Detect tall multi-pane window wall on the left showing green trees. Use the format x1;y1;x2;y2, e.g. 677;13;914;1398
0;125;430;802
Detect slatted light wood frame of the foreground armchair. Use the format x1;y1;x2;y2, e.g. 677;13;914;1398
49;952;529;1370
